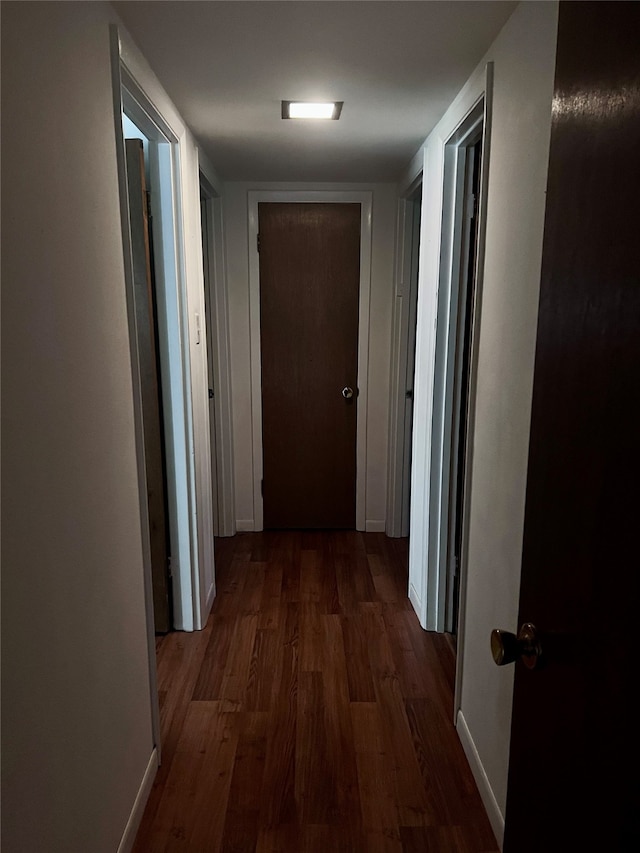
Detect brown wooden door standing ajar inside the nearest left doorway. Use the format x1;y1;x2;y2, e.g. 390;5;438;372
125;139;172;633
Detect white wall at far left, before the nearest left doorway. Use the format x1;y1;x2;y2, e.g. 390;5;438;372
2;3;153;853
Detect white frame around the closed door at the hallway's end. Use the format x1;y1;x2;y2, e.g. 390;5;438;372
248;190;372;530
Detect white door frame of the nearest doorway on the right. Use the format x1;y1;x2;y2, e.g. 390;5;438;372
409;62;493;644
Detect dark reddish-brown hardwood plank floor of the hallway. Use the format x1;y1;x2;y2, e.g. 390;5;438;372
134;531;498;853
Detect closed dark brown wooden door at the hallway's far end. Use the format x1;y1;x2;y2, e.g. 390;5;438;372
258;203;360;528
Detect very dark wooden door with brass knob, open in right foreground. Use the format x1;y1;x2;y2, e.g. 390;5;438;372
504;2;640;853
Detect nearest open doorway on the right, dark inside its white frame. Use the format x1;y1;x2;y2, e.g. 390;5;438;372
429;98;488;664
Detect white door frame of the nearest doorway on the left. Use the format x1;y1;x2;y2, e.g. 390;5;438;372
111;25;202;644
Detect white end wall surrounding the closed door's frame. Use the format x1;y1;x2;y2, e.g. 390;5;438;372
223;183;397;530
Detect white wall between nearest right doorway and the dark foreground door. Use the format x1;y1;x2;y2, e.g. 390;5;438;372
461;2;558;815
